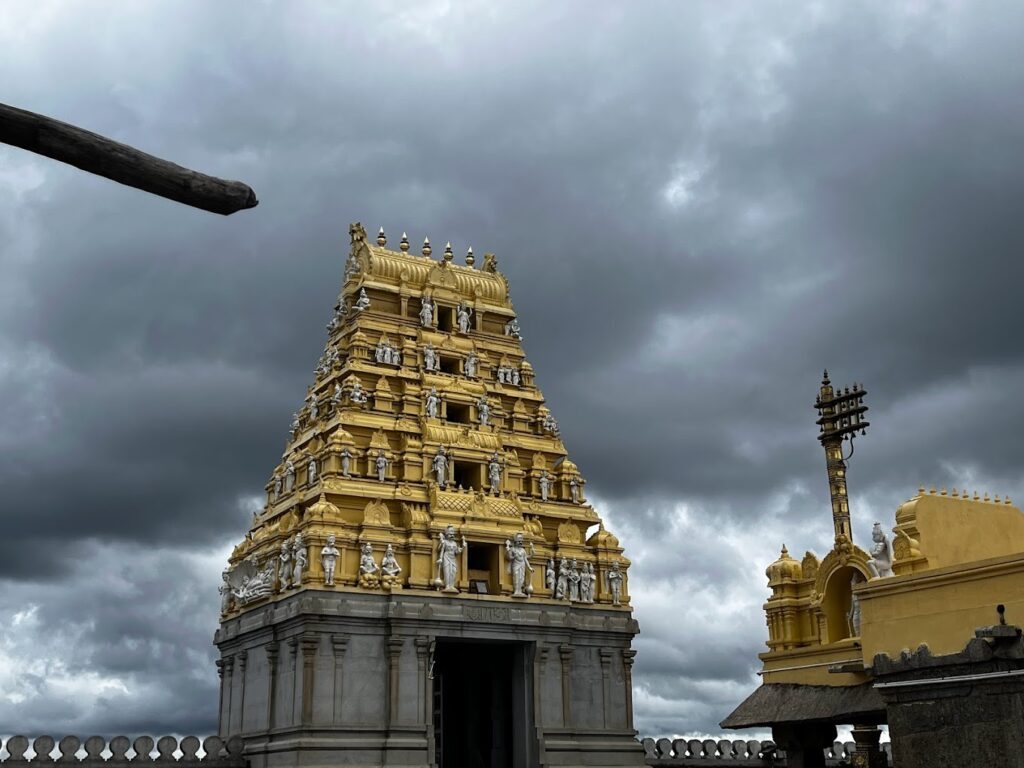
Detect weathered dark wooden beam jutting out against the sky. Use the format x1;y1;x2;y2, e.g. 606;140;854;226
0;103;259;216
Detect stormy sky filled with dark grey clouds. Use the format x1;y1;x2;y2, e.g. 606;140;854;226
0;0;1024;736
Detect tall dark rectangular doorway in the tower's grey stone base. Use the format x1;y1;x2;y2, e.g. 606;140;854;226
433;639;537;768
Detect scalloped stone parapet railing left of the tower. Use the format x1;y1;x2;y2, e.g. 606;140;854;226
0;736;248;768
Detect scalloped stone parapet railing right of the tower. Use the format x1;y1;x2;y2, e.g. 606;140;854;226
641;738;892;768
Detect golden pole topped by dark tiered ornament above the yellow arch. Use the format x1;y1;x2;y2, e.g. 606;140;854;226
814;371;869;544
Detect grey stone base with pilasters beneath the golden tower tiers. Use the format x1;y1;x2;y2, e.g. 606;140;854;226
215;588;644;768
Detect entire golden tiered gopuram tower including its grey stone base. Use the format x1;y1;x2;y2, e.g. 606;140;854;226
215;223;644;768
